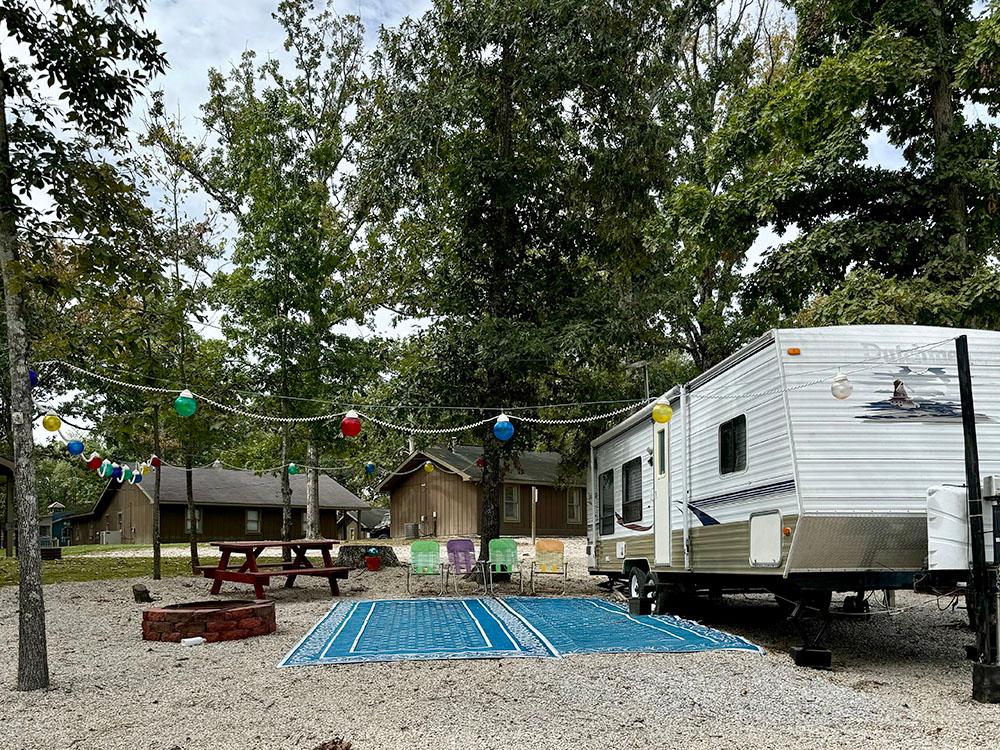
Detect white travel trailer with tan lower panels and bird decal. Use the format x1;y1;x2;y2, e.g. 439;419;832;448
588;325;1000;603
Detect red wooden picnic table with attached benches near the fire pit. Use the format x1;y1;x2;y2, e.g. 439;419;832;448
199;539;348;599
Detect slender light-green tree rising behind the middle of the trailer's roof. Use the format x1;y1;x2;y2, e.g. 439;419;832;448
637;0;789;370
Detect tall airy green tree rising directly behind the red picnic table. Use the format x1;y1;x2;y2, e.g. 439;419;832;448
154;0;379;539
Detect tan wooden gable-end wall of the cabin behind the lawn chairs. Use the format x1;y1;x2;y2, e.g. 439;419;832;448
389;469;479;537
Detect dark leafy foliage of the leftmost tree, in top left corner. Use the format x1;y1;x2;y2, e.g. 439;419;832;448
0;0;165;268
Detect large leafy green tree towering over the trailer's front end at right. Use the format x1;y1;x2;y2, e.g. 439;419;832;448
726;0;1000;324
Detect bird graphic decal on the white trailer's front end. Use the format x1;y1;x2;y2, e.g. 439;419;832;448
856;366;994;422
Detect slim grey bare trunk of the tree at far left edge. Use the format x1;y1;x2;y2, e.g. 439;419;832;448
0;45;49;690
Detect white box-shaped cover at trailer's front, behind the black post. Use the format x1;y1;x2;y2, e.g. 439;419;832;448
927;487;993;570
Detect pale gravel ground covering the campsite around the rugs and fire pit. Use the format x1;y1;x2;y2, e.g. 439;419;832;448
0;543;1000;750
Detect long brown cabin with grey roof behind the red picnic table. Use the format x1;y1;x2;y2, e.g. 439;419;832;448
68;466;368;544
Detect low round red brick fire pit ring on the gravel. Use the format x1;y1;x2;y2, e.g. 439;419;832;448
142;599;277;643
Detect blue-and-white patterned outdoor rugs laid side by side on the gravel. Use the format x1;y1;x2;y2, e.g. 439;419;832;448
279;597;762;667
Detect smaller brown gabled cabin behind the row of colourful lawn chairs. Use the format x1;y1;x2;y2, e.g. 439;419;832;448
378;445;587;538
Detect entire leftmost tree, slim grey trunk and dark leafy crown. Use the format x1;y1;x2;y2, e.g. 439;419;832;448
0;0;164;690
